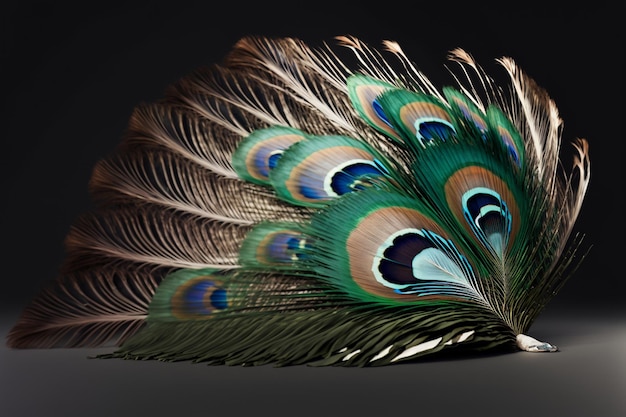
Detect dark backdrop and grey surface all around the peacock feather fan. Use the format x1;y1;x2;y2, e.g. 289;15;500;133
0;1;626;417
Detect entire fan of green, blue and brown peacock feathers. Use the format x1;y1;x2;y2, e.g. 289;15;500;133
8;36;590;366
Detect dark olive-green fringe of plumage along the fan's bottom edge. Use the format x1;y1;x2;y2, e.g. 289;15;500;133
100;303;515;367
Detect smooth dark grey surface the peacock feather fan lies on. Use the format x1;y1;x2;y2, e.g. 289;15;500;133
0;306;626;417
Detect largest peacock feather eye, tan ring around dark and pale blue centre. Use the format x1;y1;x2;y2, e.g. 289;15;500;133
342;202;483;303
